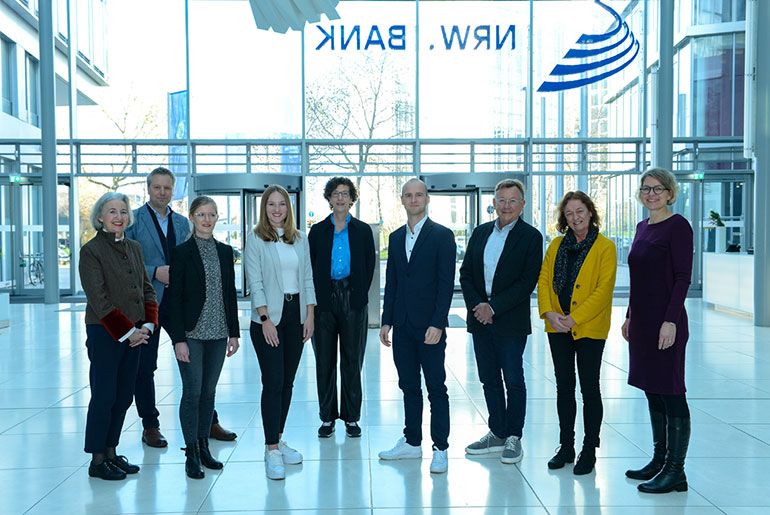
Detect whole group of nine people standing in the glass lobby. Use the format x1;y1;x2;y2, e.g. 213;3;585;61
81;168;693;493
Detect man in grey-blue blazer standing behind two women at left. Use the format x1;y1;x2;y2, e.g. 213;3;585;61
126;166;236;447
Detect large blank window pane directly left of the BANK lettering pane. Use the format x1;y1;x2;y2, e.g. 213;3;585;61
190;0;300;139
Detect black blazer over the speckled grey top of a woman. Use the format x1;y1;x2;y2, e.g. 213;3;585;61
167;237;241;343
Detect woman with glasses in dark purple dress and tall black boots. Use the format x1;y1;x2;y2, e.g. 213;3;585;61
622;168;693;493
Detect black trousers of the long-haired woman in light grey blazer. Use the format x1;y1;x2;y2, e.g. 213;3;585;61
249;295;304;445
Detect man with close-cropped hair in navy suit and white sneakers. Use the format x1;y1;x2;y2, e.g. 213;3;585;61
380;179;456;474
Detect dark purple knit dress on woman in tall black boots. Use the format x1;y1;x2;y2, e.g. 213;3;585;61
628;215;693;395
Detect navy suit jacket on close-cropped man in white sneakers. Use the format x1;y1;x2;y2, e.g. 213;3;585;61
382;218;452;330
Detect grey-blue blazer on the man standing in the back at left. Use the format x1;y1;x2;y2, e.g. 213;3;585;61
126;204;190;304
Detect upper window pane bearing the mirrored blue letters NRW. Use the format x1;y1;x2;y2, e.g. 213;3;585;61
420;1;529;138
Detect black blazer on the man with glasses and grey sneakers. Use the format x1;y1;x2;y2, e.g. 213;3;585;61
460;218;543;336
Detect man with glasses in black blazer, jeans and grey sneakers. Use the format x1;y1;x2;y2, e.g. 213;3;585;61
460;179;543;463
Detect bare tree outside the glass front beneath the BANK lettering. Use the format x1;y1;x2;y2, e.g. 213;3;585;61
305;52;414;245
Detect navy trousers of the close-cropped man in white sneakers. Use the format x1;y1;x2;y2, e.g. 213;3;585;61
393;323;449;450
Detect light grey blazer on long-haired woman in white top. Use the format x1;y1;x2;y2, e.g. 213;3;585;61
248;231;316;325
